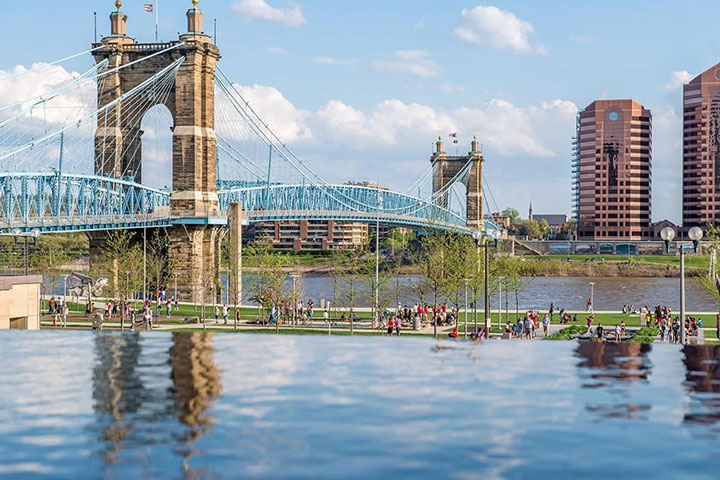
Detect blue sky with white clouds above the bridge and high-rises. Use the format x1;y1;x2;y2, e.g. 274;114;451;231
0;0;720;222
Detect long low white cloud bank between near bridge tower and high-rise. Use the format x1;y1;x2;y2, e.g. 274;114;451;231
239;85;577;157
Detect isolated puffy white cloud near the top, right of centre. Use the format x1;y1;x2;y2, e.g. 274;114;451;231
455;5;547;54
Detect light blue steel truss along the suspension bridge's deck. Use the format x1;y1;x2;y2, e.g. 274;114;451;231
0;172;494;234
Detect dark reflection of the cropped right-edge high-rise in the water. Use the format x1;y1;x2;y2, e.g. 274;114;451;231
683;345;720;425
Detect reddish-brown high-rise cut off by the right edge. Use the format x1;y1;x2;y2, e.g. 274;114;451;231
683;63;720;230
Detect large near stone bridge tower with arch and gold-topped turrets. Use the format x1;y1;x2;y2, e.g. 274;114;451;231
91;0;224;301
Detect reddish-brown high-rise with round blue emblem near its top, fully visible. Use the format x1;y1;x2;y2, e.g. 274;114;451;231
573;100;652;241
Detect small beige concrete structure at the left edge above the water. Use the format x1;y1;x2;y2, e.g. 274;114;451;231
0;275;42;330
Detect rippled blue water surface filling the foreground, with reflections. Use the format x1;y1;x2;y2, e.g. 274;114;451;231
0;332;720;479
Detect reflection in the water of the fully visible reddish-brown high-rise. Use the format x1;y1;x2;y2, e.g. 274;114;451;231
575;341;652;419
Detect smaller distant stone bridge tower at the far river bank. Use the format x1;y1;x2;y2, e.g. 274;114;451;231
430;137;485;230
